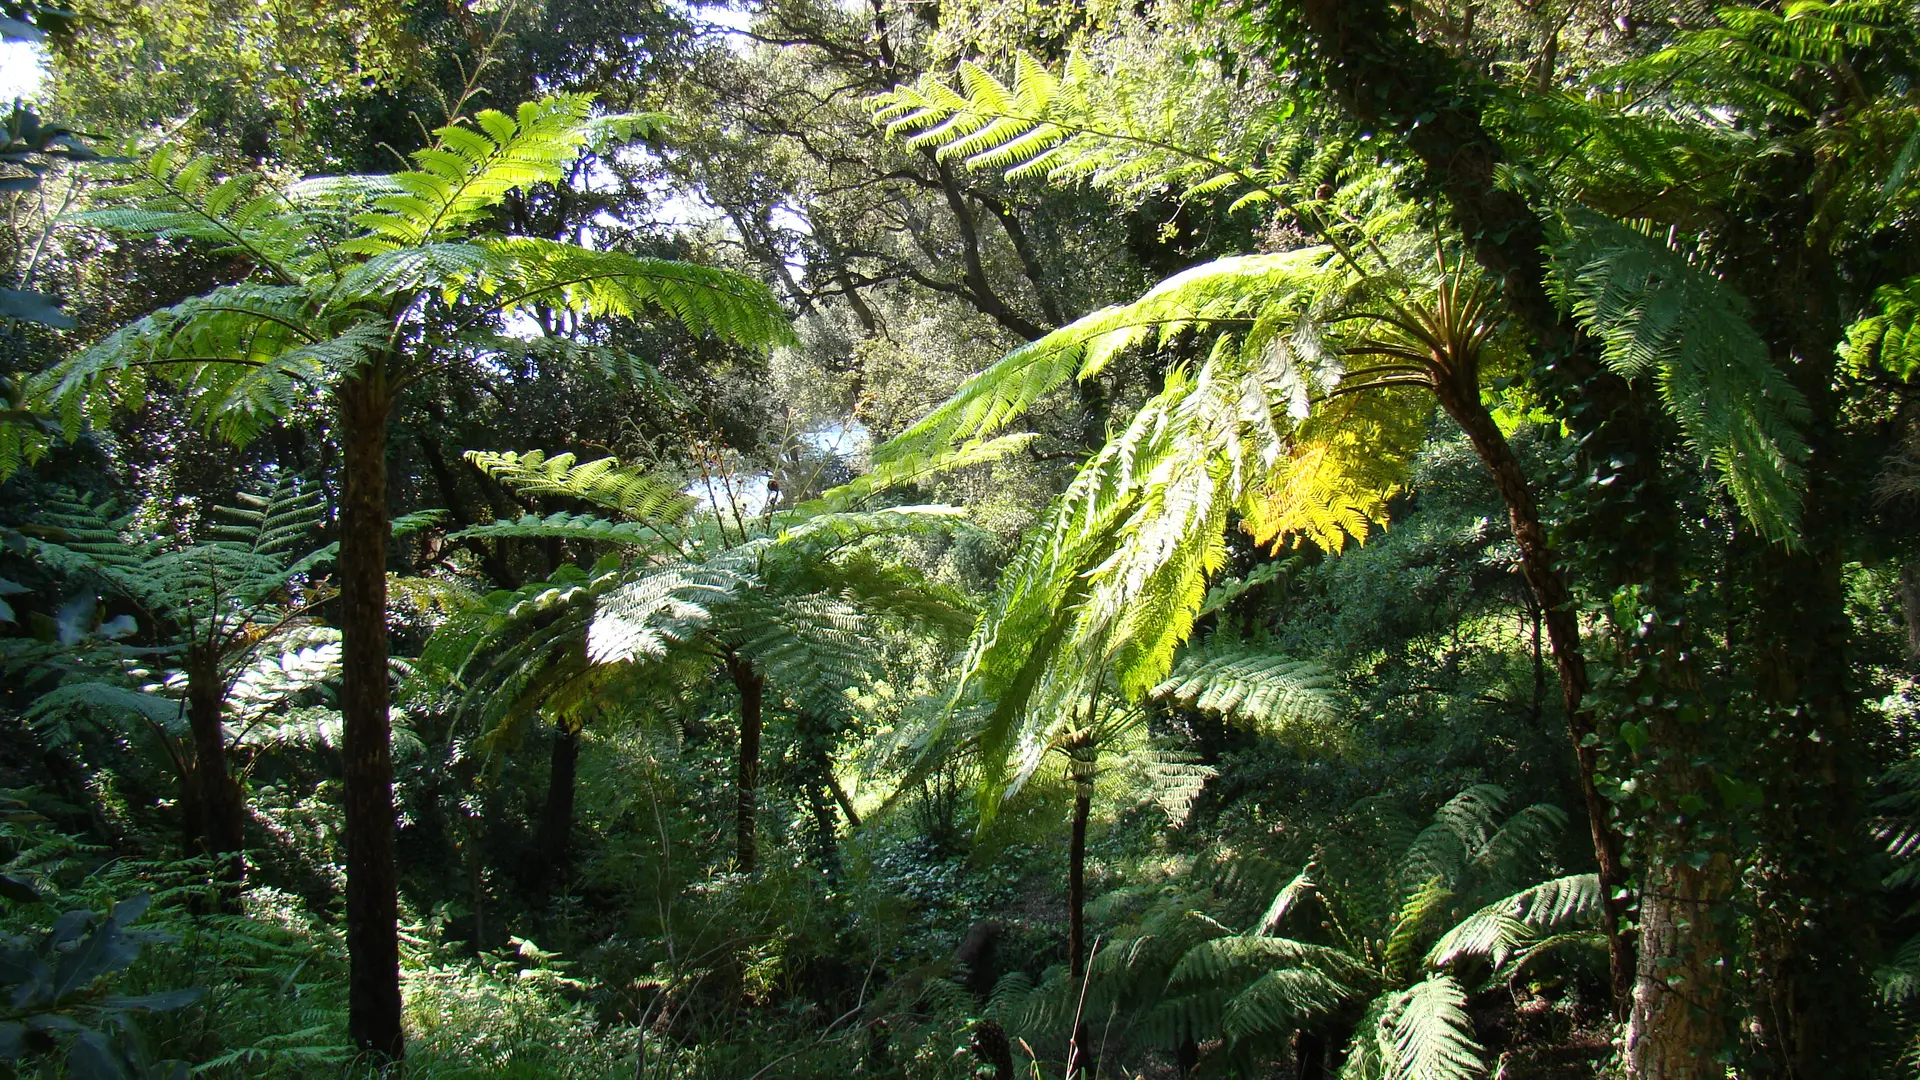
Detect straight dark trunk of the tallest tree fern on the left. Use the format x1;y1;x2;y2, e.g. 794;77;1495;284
338;369;405;1061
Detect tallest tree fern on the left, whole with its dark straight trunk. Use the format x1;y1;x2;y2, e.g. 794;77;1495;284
29;96;789;1059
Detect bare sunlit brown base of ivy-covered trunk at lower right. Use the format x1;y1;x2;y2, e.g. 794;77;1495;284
1626;851;1732;1080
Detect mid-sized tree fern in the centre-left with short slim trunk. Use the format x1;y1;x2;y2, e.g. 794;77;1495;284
419;441;970;869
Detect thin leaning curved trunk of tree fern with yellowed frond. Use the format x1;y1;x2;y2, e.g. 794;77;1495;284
1436;374;1634;1001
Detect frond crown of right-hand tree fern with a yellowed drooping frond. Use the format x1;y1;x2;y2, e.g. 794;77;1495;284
876;56;1801;772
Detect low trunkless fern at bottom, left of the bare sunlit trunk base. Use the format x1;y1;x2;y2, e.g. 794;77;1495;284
1169;786;1599;1080
